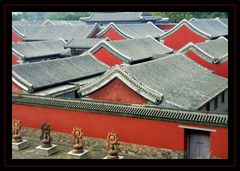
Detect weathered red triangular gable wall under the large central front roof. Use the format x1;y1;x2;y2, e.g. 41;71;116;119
89;78;148;104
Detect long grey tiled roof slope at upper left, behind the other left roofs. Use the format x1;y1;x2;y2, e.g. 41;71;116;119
15;25;98;40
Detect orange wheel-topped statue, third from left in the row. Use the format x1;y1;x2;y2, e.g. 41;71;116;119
72;128;84;153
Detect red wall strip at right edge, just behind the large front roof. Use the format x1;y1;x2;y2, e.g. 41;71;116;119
185;51;228;78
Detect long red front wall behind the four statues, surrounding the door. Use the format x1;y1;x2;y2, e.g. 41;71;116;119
12;104;228;158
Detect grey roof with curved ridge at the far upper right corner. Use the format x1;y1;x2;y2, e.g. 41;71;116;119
161;18;228;39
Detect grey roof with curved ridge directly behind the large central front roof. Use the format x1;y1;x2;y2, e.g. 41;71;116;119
89;37;173;64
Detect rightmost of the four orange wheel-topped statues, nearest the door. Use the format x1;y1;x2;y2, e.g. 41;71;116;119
106;132;119;159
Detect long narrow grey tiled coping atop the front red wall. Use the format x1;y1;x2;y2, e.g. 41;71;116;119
12;94;228;127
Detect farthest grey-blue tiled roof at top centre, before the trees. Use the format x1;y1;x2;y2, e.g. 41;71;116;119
81;12;160;22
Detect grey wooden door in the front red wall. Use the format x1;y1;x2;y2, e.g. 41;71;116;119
187;130;210;159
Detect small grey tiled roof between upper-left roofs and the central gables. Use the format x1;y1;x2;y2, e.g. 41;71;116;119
65;38;104;49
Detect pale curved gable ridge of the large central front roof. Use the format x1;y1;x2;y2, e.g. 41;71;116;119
79;65;163;104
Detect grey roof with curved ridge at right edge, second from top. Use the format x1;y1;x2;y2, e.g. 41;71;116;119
179;37;228;63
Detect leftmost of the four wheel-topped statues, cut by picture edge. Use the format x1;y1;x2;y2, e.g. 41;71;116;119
12;119;22;143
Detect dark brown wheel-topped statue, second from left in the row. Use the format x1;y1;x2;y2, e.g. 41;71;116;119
40;122;52;148
